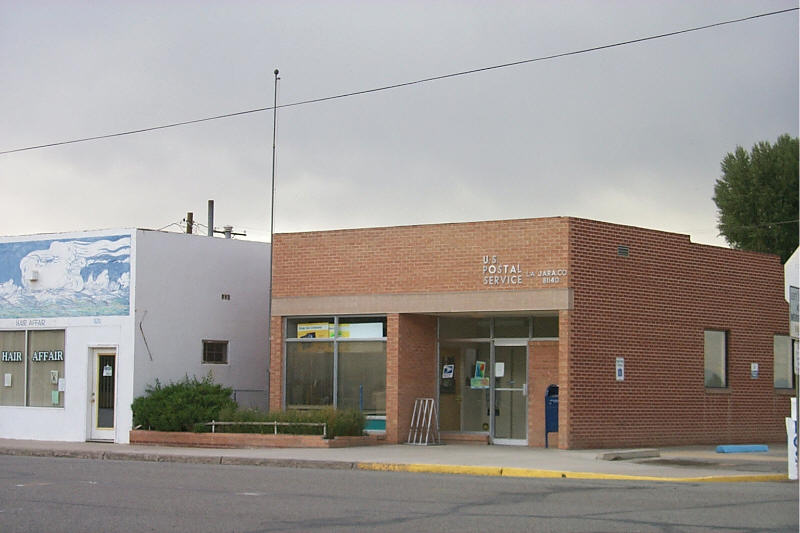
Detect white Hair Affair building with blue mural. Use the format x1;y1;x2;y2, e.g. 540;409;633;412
0;229;269;443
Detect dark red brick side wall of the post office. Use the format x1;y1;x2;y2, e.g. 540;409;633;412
561;219;789;448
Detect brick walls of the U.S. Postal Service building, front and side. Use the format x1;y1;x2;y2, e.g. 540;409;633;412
270;218;789;448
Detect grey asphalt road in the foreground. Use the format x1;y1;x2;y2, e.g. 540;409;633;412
0;456;798;533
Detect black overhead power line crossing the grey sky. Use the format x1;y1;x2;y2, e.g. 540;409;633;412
0;7;800;155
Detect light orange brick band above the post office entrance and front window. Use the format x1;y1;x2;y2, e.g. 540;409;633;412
273;218;569;298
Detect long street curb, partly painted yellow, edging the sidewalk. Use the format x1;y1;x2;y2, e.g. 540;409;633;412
0;448;789;483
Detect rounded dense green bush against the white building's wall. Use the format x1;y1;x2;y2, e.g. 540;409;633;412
131;374;236;431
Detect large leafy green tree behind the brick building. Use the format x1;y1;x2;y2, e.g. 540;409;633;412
714;134;798;263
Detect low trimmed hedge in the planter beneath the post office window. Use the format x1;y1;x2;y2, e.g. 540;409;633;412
208;407;366;439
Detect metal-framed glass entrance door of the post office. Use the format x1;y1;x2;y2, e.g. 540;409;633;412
492;344;528;445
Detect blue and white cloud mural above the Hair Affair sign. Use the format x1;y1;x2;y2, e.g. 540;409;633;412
0;235;131;318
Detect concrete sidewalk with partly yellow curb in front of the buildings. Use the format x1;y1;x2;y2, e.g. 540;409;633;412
0;439;788;482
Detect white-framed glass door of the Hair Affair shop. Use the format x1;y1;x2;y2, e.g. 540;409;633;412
90;349;117;441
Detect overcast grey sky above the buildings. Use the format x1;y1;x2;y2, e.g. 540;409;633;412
0;0;798;245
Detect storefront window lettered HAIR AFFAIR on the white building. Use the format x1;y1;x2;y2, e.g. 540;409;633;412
0;330;64;407
